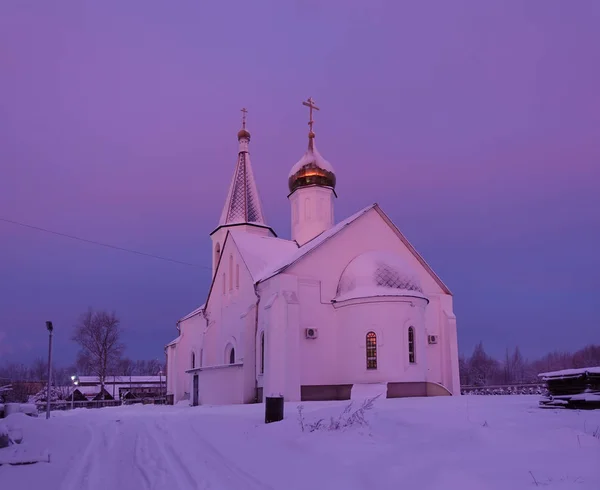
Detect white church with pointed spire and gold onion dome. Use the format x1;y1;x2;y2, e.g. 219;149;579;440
165;98;460;405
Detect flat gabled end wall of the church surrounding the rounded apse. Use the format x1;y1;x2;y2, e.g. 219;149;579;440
286;210;460;396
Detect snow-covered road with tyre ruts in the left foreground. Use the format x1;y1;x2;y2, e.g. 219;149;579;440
60;411;269;490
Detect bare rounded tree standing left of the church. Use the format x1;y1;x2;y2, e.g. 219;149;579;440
73;308;124;393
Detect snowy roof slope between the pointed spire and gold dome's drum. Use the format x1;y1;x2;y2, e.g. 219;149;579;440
229;230;298;281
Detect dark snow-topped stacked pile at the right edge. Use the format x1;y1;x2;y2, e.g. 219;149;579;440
538;366;600;408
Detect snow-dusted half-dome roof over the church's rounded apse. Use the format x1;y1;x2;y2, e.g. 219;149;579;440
335;250;427;301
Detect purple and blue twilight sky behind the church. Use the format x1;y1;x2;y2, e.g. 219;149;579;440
0;0;600;364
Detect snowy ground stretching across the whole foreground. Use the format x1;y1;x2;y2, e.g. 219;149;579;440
0;396;600;490
